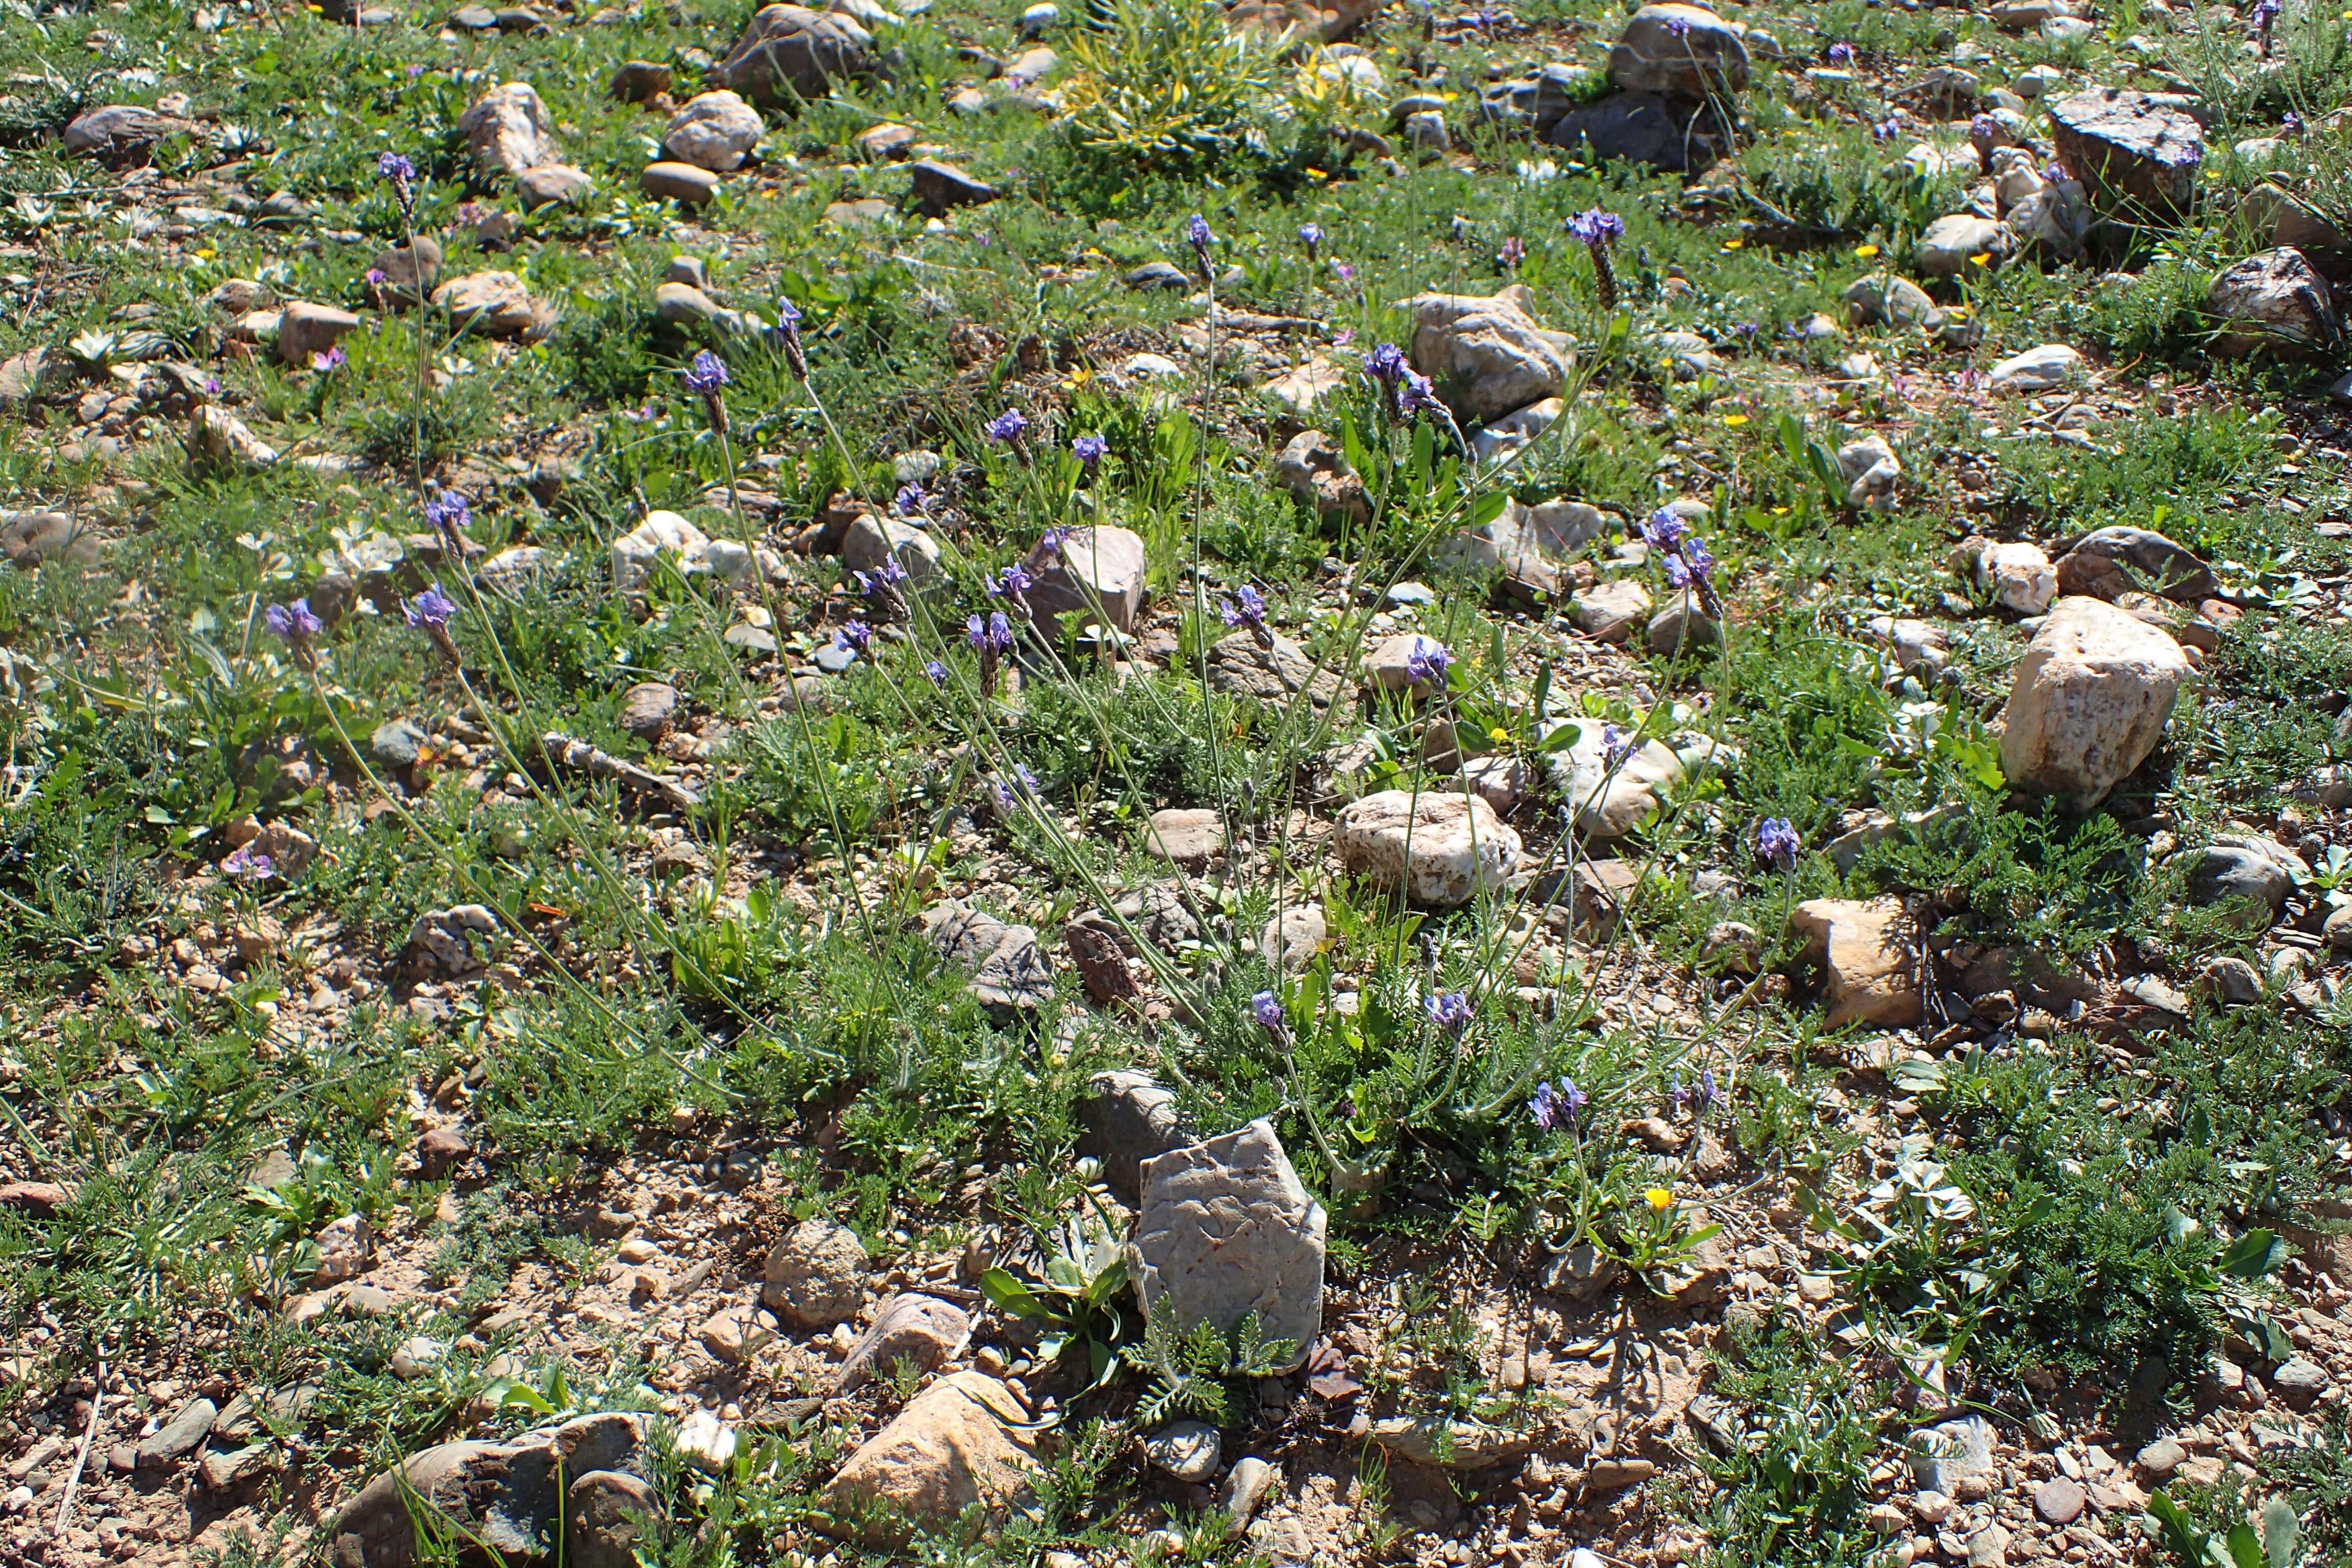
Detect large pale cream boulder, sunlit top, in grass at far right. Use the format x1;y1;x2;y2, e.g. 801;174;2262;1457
2001;597;2190;811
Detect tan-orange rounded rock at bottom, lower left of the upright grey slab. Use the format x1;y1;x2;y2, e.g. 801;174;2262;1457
828;1373;1037;1545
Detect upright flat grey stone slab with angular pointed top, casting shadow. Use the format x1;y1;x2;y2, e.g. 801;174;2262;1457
1129;1119;1329;1373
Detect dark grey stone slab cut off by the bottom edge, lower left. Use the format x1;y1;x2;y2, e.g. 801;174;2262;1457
327;1410;645;1568
